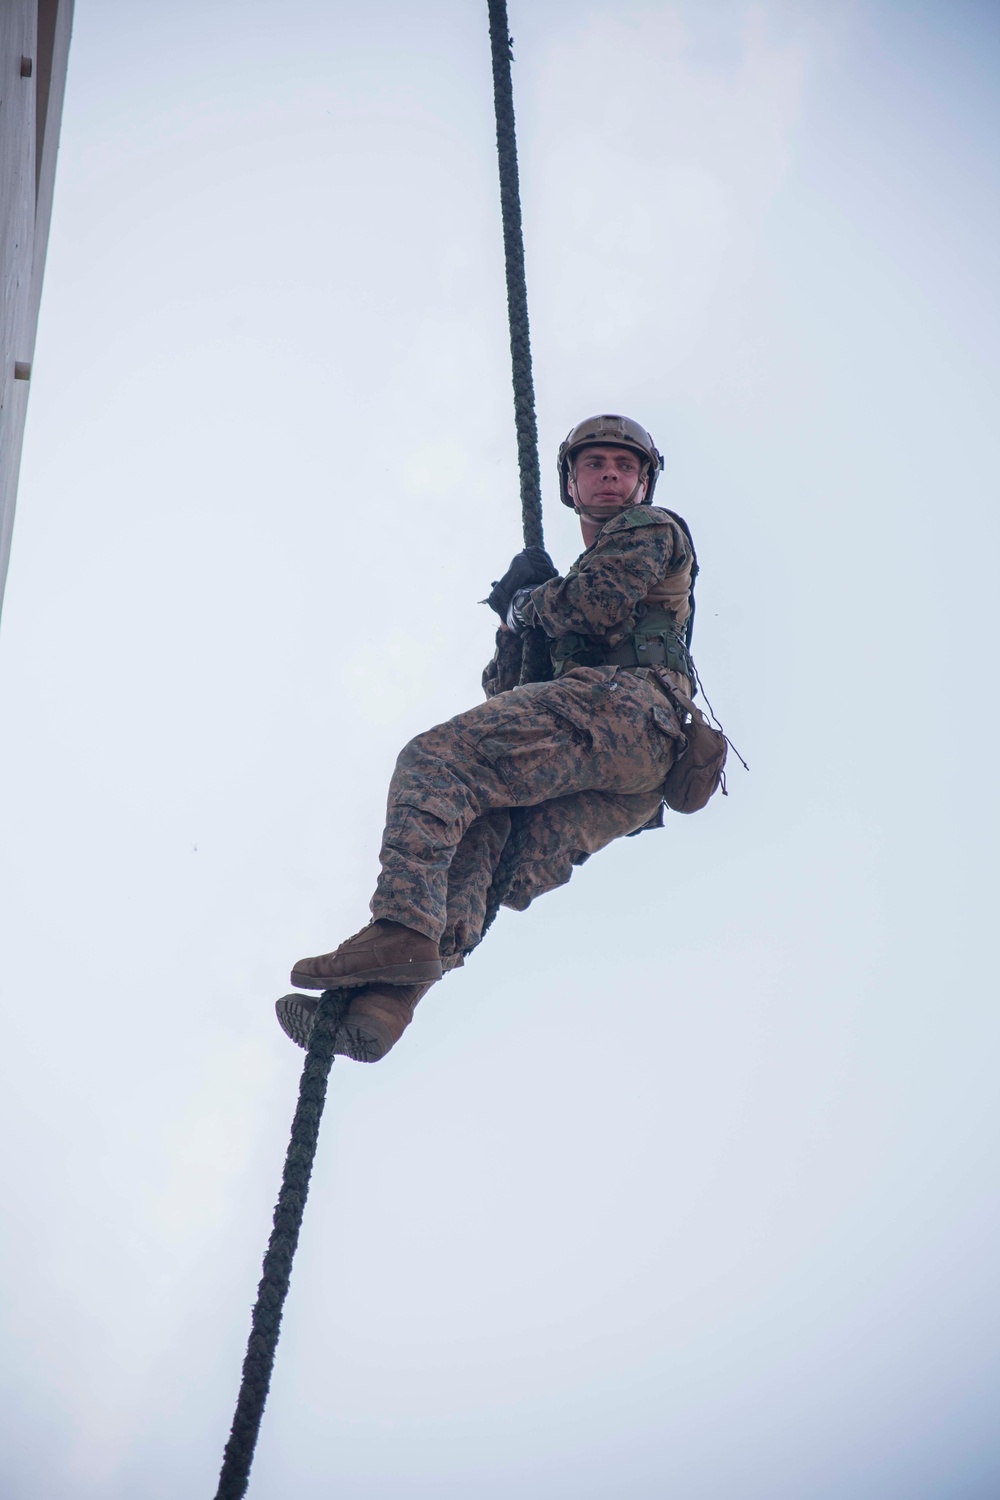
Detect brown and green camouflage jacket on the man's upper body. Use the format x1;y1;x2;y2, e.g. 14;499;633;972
483;506;696;698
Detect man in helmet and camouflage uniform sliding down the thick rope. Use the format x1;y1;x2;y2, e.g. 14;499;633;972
277;416;714;1062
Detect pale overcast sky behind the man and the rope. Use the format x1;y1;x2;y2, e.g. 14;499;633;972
0;0;1000;1500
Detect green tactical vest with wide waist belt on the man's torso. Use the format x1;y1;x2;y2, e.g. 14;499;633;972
549;506;699;686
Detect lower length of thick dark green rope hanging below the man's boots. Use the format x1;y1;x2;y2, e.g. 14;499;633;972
216;990;352;1500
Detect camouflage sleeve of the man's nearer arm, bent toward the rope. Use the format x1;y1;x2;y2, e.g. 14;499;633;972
525;512;690;639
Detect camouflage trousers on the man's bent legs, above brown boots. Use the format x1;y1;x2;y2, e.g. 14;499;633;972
372;666;682;968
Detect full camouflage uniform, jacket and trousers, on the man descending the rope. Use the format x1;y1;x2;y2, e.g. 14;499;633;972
372;506;693;968
